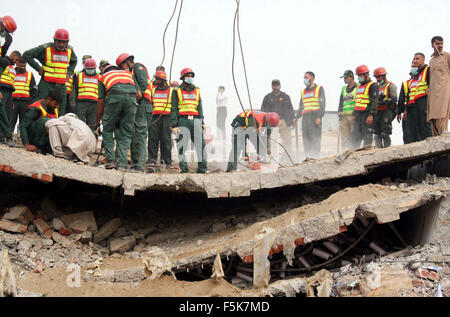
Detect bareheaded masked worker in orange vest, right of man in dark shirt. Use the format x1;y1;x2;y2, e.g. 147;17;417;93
296;72;326;159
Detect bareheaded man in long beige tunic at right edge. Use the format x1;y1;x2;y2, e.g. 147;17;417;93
427;36;450;136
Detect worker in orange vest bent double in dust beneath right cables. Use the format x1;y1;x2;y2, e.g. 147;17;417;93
227;111;280;172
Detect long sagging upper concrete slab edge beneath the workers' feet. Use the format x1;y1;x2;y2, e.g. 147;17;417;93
0;133;450;198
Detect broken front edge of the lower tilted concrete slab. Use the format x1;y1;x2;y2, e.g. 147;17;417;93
166;184;450;272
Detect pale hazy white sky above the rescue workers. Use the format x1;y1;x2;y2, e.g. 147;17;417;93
0;0;450;144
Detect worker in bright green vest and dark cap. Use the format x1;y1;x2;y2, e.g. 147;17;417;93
338;70;357;148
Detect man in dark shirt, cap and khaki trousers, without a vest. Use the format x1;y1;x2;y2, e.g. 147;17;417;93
261;79;297;156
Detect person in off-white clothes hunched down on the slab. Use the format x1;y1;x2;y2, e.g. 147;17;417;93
45;113;97;164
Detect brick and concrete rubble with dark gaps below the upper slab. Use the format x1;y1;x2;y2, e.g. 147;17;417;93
0;168;450;297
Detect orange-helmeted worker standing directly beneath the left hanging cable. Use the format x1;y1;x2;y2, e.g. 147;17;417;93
148;70;176;168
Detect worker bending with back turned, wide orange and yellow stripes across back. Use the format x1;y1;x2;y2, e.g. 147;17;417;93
95;65;142;171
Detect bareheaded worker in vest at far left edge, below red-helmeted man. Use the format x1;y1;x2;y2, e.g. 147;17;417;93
0;51;21;146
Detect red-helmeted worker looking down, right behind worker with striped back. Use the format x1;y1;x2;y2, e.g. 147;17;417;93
116;53;151;172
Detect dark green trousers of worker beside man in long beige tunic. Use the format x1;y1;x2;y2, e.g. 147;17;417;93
406;97;433;143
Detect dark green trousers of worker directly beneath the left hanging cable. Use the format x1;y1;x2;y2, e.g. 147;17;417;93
148;114;172;164
